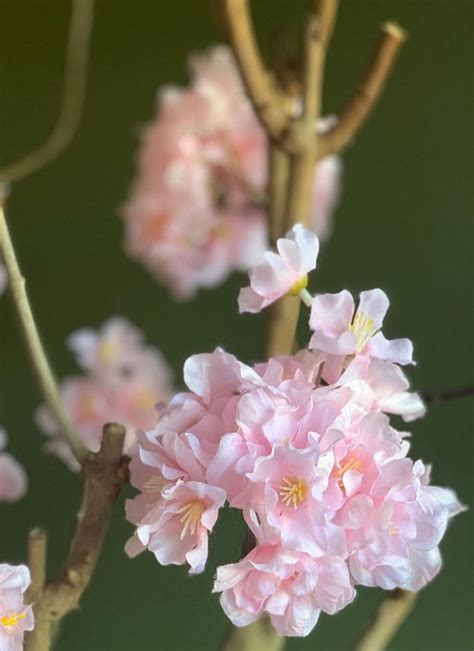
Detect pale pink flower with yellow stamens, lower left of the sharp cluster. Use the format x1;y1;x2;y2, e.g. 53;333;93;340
127;479;226;574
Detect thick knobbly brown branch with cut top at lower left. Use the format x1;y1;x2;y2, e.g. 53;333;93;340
26;423;127;651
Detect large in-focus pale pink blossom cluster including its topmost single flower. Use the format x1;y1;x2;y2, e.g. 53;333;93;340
126;225;462;636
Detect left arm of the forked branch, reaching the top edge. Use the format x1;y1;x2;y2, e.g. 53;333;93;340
220;0;288;140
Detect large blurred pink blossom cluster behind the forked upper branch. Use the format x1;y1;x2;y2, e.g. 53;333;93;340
123;46;341;300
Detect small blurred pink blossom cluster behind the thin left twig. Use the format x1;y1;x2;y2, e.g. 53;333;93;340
36;317;172;470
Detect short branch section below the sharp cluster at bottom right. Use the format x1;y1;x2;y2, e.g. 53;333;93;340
354;589;417;651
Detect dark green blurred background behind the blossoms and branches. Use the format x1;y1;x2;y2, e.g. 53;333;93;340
0;0;474;651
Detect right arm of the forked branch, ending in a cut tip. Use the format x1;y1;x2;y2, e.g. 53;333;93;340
317;22;407;159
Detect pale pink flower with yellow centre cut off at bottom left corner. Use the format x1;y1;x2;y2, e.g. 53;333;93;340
0;563;34;651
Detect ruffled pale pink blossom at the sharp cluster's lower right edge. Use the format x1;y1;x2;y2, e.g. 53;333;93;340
347;459;464;590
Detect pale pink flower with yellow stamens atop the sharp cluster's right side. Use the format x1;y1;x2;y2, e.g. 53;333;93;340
309;289;413;382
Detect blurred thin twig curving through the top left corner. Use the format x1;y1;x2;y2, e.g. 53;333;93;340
0;0;94;184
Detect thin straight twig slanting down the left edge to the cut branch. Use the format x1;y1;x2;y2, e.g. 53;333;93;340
0;202;87;463
